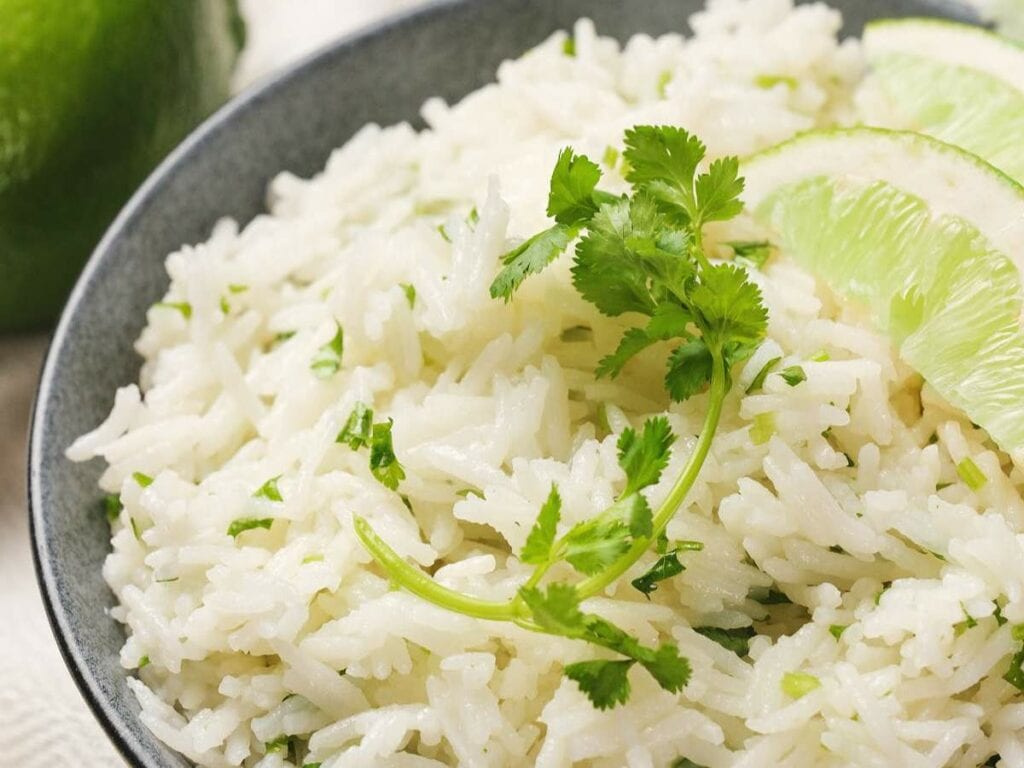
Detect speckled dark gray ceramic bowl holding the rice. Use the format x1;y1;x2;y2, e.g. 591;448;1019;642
29;0;977;768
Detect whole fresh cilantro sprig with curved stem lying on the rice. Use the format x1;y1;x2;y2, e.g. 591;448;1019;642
356;126;768;709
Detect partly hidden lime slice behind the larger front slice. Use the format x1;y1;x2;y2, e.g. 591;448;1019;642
863;18;1024;180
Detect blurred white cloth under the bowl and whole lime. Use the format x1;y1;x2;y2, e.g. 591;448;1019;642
0;0;423;768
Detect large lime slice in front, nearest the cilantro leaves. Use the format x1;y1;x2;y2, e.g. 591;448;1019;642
743;128;1024;460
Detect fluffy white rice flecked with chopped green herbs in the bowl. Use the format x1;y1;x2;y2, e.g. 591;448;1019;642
68;0;1024;768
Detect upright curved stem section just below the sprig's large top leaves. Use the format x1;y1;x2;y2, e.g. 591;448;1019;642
577;349;728;600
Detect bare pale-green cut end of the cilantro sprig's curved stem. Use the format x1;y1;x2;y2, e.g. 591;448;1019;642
352;515;529;622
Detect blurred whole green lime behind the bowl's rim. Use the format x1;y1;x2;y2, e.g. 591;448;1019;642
0;0;245;331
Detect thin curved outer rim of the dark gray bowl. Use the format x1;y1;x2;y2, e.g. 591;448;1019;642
27;0;458;768
